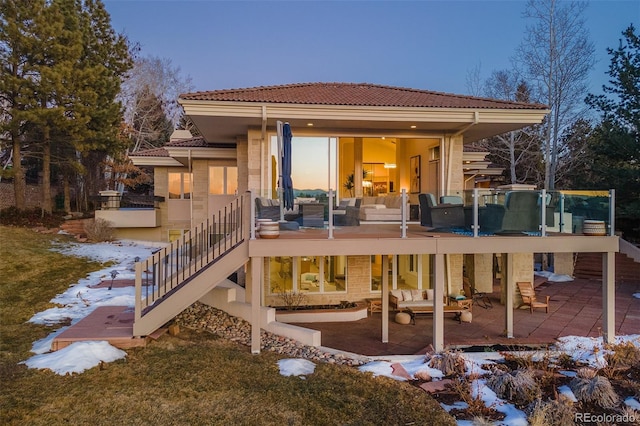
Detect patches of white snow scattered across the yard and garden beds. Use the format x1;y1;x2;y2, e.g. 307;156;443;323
24;241;640;425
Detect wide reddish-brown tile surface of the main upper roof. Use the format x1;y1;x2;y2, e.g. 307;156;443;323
180;83;547;109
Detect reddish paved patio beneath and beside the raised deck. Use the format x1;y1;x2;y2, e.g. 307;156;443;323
296;277;640;356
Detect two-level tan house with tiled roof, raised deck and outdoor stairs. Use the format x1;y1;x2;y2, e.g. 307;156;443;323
96;83;619;352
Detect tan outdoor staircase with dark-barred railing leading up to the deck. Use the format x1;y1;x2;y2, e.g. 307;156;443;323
133;195;251;336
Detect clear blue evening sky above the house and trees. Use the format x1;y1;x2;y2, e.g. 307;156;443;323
104;0;640;94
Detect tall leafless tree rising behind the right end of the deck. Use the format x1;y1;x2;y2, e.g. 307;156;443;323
514;0;595;189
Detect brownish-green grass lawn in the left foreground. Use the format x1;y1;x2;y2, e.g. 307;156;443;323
0;227;455;426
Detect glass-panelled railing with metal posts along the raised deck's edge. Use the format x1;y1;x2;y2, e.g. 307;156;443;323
252;188;615;239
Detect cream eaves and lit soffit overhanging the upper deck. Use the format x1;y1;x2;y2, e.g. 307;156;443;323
181;100;547;144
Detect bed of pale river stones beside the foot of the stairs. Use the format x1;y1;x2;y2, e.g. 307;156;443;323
175;302;369;366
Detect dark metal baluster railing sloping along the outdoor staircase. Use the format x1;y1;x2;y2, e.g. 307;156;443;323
135;195;250;318
